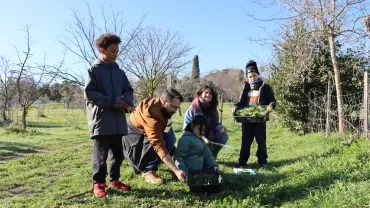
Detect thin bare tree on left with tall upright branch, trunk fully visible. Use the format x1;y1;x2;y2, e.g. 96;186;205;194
13;25;63;129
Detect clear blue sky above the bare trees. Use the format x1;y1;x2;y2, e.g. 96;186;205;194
0;0;281;75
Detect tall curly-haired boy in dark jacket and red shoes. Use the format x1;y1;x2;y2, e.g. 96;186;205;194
85;33;134;197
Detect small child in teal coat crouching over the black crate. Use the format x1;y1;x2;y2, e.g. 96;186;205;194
174;115;220;172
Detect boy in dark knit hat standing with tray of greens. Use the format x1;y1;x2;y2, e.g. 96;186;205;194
232;60;276;168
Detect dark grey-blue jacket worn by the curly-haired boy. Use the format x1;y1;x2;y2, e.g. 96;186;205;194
84;59;134;137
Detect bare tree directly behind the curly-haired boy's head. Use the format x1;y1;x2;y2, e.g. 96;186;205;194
49;2;144;86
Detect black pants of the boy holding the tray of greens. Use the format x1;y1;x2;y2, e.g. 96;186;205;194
239;122;268;165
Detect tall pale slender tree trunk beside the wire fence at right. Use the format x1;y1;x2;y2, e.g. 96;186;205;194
328;32;344;134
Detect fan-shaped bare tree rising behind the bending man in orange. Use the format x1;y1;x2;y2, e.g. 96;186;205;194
123;27;193;97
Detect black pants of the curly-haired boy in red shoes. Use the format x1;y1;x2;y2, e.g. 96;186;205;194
92;135;123;183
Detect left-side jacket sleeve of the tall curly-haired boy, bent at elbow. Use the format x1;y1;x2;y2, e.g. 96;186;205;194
84;68;119;109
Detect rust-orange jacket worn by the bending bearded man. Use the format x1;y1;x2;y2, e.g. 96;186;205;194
130;98;168;159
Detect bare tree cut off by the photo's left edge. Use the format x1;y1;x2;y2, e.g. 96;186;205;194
0;56;15;126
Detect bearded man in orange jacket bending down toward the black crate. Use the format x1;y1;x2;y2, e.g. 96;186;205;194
122;89;186;183
